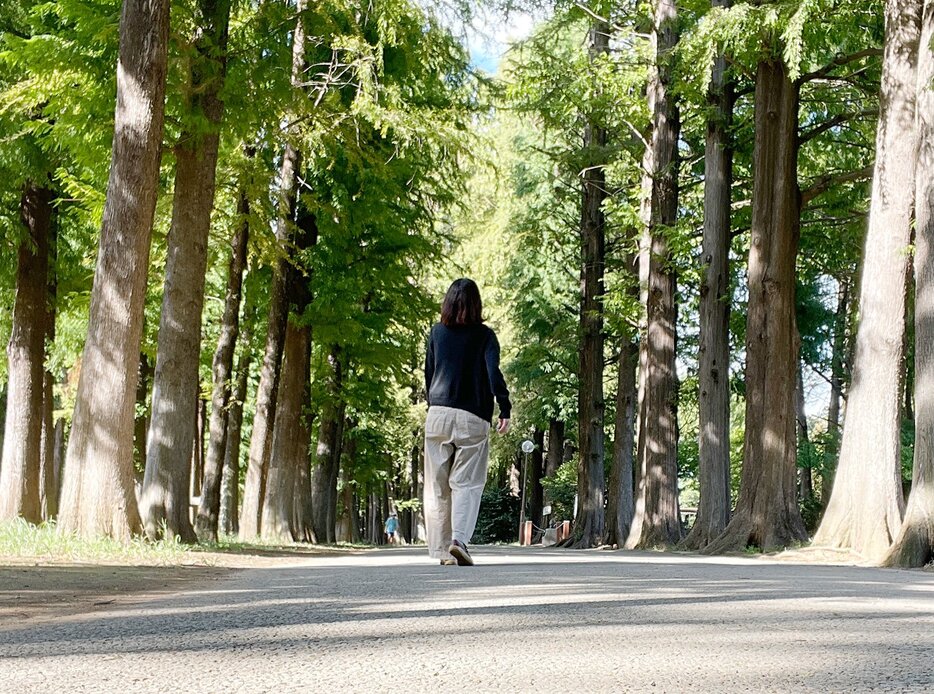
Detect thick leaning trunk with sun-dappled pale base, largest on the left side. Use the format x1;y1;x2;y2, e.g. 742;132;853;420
59;0;170;540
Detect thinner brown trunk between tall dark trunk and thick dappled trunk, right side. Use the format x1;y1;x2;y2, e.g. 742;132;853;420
606;335;639;547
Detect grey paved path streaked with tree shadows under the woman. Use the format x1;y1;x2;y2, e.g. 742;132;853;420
0;548;934;694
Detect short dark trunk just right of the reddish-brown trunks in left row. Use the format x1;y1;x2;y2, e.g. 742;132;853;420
311;346;344;543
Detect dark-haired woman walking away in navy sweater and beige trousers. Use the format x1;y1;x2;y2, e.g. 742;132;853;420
425;279;512;566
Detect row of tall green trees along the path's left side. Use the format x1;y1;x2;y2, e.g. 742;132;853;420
0;0;477;542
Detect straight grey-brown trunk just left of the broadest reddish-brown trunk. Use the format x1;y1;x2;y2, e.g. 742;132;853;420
682;0;733;549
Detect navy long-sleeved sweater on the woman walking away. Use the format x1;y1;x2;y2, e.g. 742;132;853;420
425;323;512;421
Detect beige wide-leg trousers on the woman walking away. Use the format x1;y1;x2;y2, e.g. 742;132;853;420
425;406;490;559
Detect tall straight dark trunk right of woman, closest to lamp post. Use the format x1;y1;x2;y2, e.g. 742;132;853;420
574;21;610;547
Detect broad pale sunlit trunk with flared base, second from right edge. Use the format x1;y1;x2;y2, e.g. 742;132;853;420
814;0;924;560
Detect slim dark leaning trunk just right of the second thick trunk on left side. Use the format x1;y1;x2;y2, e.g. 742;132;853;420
195;186;250;541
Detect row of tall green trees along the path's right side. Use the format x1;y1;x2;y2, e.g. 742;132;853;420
478;0;932;565
